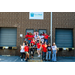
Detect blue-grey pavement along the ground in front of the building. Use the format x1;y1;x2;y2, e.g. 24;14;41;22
0;55;75;62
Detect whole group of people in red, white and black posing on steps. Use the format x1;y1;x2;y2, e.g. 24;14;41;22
20;33;57;61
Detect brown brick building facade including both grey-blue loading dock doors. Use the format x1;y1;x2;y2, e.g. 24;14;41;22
0;12;75;56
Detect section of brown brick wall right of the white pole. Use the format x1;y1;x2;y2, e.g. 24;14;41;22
53;12;75;56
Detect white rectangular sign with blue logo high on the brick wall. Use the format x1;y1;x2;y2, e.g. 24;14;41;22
29;12;44;20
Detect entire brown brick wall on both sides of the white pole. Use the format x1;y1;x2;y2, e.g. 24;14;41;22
0;12;75;56
